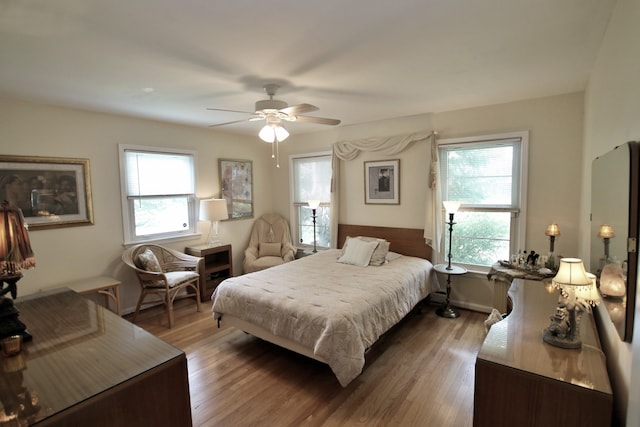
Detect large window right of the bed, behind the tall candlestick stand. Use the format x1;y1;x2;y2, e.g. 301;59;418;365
439;132;528;271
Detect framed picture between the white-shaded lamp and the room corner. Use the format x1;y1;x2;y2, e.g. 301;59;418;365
218;159;253;219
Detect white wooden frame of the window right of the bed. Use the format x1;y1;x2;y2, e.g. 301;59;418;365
438;131;529;273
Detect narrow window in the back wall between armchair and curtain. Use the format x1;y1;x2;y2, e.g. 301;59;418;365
289;153;331;248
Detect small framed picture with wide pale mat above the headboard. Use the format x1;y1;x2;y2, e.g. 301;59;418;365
364;159;400;205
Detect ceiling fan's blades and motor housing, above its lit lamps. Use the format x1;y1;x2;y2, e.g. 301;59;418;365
207;83;340;131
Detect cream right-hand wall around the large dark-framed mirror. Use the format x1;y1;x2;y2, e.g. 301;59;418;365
580;0;640;426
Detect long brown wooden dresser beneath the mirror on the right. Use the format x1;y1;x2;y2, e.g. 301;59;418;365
473;279;613;427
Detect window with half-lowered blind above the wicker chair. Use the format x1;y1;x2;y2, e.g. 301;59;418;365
119;145;196;243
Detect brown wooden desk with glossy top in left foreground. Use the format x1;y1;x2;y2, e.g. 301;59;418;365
0;289;191;426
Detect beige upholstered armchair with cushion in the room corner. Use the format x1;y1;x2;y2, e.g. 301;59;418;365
243;214;296;273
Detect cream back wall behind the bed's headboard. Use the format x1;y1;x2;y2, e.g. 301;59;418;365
274;93;584;311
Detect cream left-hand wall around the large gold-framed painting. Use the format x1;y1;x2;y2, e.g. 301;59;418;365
0;99;273;312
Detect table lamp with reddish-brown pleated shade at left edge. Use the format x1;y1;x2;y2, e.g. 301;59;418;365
0;201;36;341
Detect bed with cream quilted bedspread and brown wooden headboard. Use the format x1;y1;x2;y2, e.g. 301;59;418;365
211;224;435;387
